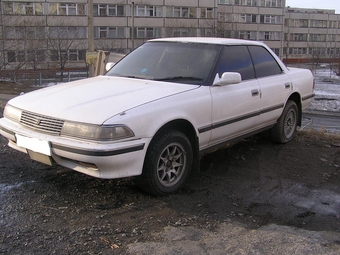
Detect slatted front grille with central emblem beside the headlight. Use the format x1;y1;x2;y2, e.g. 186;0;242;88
20;111;64;135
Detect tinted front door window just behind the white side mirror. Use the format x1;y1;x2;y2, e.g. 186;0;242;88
218;46;255;80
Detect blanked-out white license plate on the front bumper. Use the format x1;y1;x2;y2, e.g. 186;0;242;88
15;134;52;156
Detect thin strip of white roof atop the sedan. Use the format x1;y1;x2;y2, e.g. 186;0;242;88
149;37;264;46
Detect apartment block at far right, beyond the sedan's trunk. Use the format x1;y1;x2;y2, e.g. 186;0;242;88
283;7;340;63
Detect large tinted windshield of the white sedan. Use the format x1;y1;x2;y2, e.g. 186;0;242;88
106;42;220;85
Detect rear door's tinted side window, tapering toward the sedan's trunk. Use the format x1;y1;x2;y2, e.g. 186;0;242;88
248;46;282;78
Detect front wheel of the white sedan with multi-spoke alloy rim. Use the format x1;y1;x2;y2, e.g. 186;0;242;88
139;130;193;195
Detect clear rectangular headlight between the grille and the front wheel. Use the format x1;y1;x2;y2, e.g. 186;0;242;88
61;122;134;141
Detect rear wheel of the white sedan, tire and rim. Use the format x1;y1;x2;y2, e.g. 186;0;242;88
271;100;299;143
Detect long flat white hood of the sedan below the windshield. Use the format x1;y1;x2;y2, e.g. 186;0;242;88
9;76;198;124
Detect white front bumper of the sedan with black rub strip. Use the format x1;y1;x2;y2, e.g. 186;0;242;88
0;118;150;179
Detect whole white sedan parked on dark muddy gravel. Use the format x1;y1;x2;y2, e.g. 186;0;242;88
0;38;314;195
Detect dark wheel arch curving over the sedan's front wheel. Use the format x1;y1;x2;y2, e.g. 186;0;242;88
148;119;200;171
